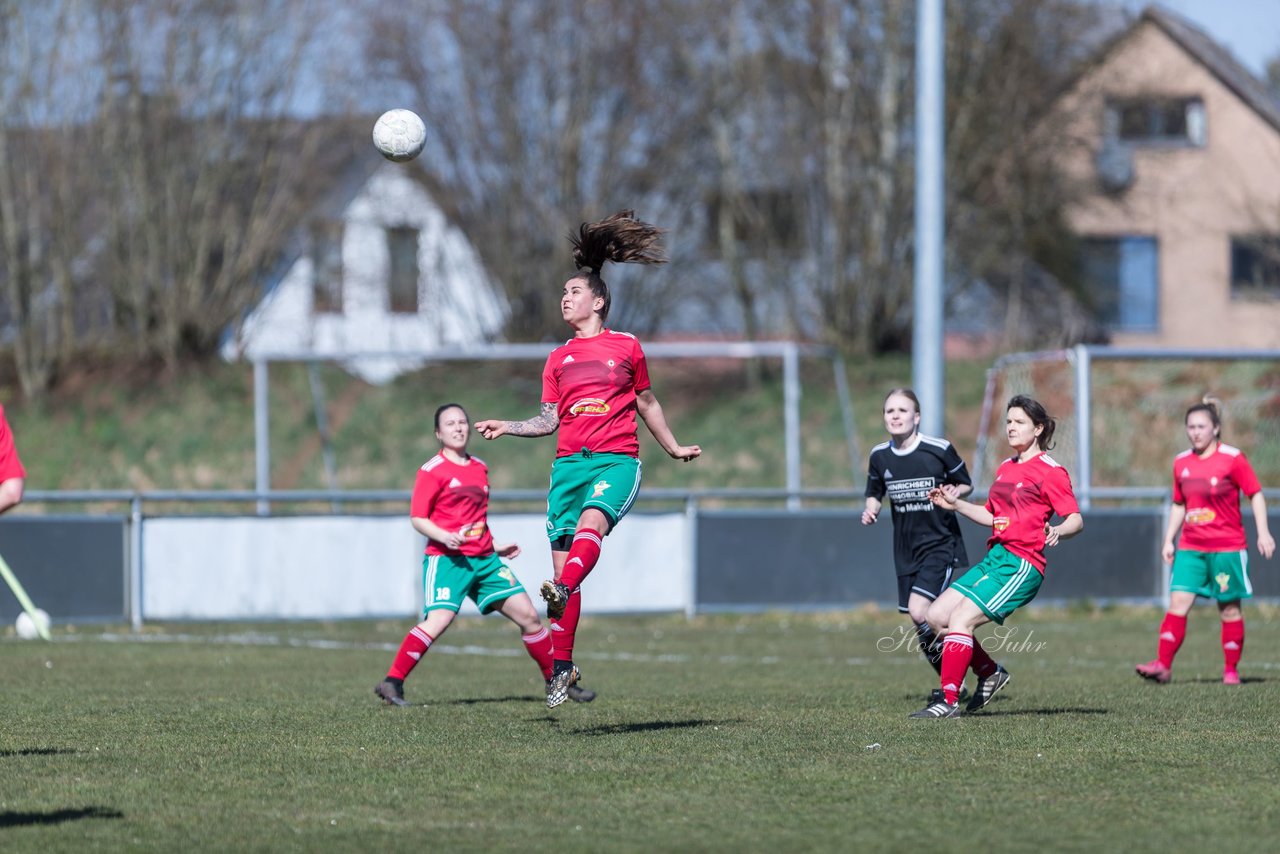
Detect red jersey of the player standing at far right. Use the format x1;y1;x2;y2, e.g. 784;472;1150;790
1174;442;1262;552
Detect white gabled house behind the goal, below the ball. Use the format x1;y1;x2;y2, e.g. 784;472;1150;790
221;161;508;383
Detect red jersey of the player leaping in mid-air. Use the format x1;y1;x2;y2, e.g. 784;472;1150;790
543;329;649;457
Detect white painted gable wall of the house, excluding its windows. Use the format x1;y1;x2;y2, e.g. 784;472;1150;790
223;163;507;383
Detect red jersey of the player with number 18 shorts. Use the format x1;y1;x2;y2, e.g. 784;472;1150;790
408;453;493;557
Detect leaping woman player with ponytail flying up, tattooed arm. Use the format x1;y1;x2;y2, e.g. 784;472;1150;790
476;210;701;708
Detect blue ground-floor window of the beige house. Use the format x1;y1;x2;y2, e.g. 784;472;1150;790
1082;237;1160;332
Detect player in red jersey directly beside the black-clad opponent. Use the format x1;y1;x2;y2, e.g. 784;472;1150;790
911;394;1084;718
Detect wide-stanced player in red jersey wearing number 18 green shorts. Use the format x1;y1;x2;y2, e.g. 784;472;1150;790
374;403;595;705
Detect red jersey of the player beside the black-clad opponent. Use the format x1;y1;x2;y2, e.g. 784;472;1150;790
987;453;1080;575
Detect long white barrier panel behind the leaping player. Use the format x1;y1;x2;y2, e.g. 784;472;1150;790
142;513;692;620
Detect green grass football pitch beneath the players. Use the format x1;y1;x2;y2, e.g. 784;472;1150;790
0;606;1280;853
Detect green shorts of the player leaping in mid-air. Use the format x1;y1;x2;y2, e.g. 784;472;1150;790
547;451;640;544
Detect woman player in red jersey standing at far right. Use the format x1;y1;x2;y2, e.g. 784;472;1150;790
1134;398;1276;685
